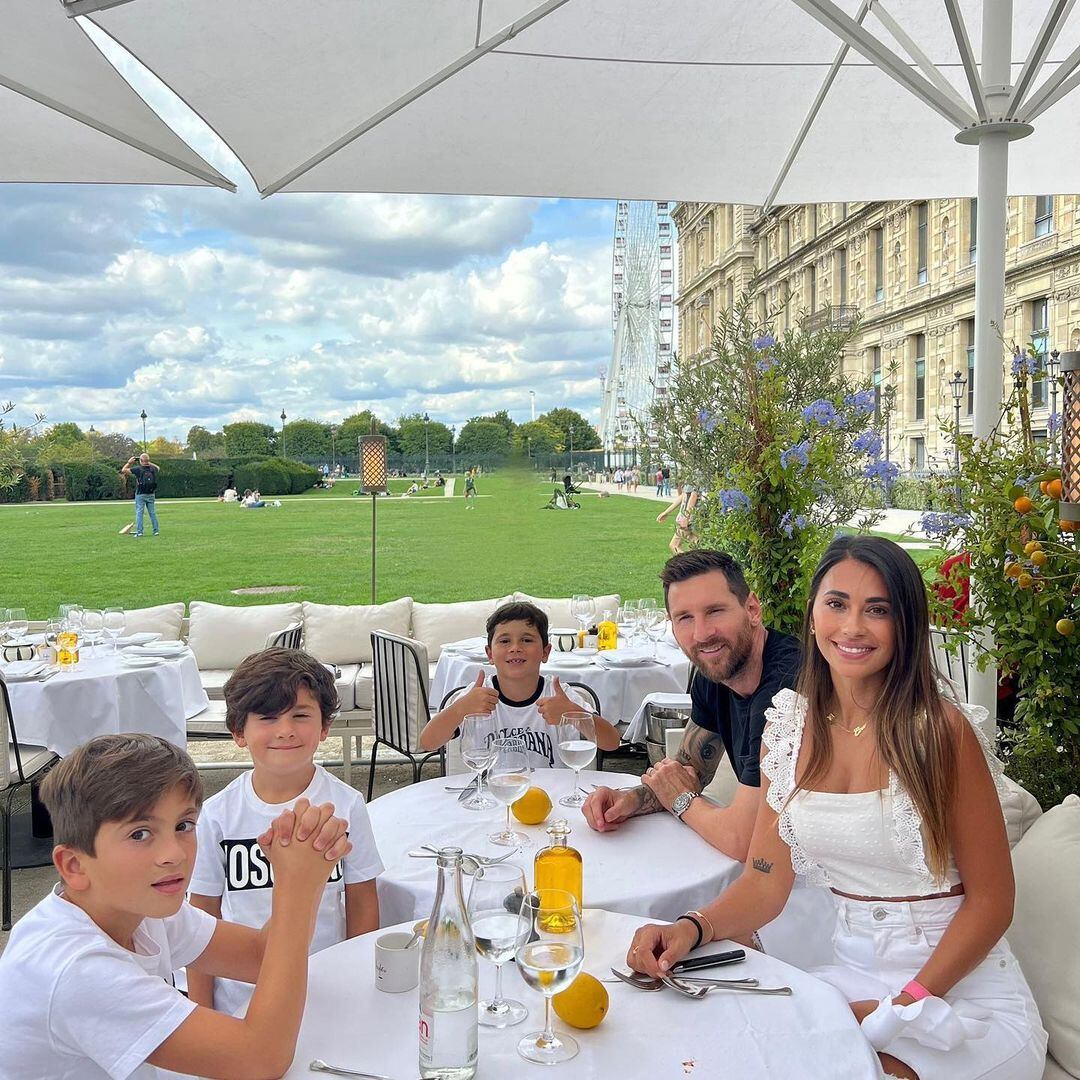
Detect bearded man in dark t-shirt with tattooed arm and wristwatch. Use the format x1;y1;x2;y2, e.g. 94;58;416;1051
582;551;800;862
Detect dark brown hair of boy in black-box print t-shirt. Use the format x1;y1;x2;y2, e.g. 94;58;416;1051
225;649;340;735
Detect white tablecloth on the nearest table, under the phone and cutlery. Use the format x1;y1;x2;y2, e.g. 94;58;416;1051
285;910;881;1080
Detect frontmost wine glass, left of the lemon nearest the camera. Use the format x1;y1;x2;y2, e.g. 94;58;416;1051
514;889;585;1065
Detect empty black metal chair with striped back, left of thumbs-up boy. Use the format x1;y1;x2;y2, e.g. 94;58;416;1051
367;630;446;801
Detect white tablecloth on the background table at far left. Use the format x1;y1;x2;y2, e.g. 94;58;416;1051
8;646;210;756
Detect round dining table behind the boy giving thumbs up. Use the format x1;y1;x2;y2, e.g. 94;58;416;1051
431;638;690;724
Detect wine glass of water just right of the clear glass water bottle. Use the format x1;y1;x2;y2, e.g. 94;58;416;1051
469;863;529;1027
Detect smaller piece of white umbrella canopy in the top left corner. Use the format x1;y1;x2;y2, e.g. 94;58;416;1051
0;0;233;190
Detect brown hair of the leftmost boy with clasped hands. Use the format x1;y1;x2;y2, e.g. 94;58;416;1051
41;734;203;855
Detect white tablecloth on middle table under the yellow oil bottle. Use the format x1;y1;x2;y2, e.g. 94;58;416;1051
367;769;742;922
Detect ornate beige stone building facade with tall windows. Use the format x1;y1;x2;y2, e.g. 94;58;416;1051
673;195;1080;470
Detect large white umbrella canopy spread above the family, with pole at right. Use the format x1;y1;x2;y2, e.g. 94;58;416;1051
76;0;1080;205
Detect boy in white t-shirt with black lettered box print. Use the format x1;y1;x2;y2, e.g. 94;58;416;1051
188;649;382;1013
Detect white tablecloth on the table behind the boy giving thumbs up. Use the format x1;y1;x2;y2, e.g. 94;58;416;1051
431;642;690;724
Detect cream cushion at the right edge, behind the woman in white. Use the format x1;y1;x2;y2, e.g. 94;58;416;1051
1008;795;1080;1076
